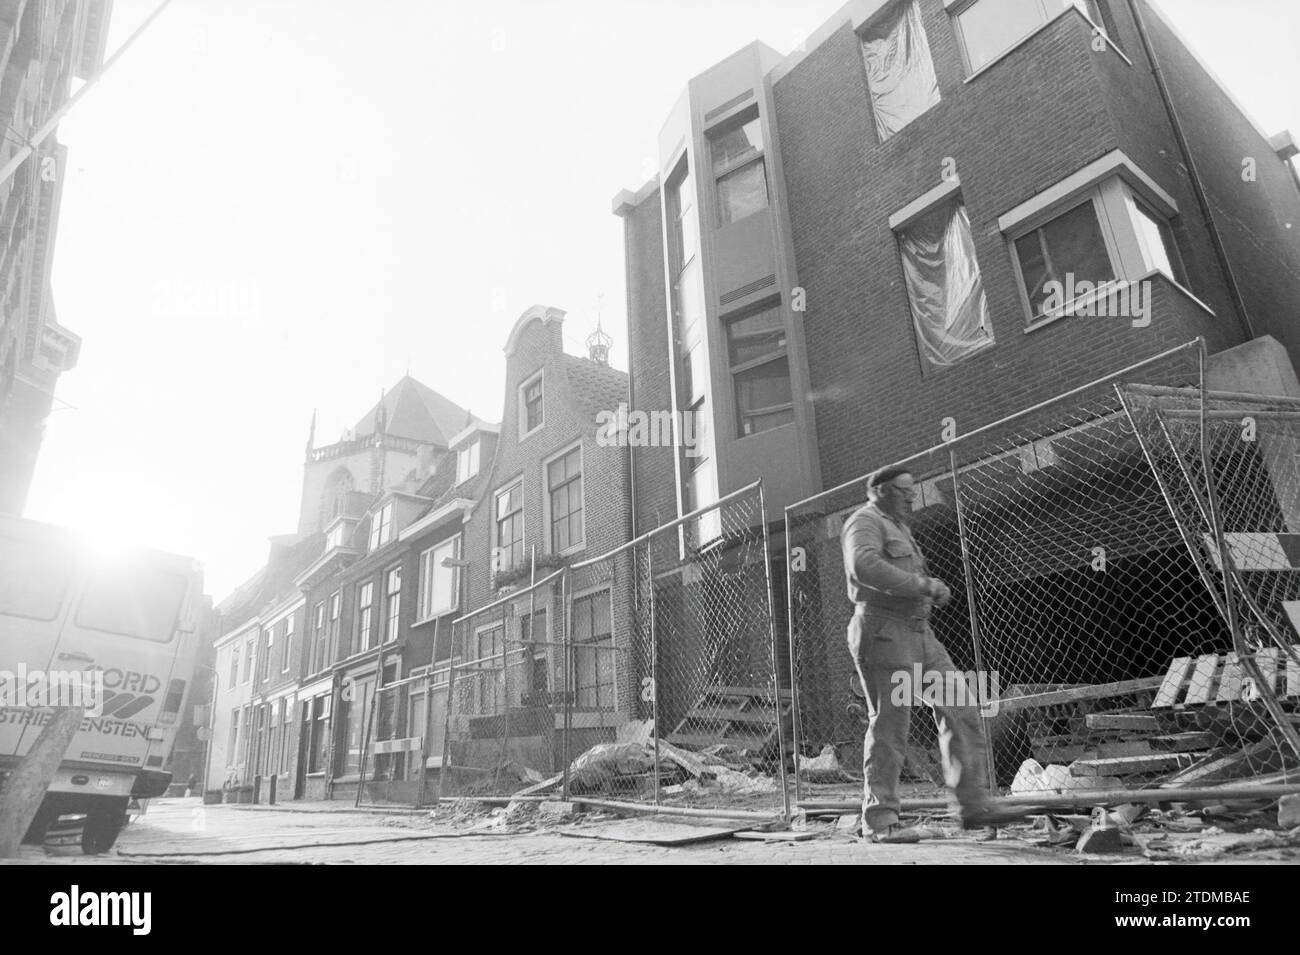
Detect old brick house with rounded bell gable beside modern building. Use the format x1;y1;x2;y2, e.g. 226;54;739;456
434;305;638;770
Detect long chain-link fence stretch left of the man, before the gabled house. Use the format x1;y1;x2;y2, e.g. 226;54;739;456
430;485;790;816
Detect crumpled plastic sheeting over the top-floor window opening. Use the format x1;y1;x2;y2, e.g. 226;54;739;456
862;1;939;142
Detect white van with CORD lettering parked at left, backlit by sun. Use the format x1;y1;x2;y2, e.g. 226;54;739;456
0;517;203;852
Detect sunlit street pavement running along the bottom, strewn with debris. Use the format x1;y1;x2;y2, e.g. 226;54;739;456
14;798;1300;865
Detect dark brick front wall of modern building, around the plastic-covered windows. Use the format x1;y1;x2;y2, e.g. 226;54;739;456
774;0;1240;486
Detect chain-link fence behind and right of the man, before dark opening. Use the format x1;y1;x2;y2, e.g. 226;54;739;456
785;342;1300;796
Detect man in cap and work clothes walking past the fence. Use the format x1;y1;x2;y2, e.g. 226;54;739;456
841;468;1010;842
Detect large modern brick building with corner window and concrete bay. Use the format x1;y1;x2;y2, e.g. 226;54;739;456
615;0;1300;526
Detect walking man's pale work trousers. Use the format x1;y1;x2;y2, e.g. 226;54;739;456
849;612;989;832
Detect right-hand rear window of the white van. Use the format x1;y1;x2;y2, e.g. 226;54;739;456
77;565;186;643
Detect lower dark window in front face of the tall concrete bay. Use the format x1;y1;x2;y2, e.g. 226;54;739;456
728;303;794;437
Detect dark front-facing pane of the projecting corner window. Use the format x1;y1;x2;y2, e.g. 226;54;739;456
1015;196;1115;322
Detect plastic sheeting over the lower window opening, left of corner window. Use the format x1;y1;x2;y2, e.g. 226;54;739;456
898;200;993;368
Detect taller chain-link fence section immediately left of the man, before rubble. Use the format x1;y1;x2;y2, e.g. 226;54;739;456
566;485;790;812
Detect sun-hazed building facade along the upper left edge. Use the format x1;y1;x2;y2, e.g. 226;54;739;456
0;0;113;515
